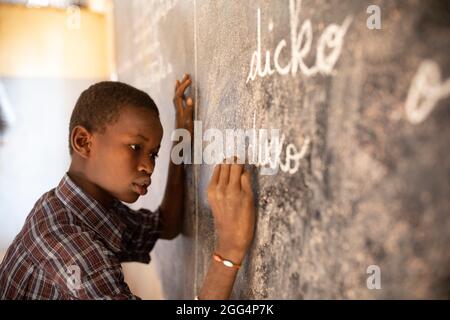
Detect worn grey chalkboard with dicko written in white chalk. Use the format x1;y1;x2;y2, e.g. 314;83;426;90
115;0;450;299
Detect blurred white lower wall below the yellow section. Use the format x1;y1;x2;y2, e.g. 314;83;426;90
0;78;96;250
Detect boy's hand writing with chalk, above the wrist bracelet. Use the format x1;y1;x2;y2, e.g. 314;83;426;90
208;159;256;264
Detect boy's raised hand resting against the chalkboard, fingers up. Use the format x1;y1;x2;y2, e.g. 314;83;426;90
173;74;194;137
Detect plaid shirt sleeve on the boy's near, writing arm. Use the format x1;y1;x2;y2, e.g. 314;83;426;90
35;229;140;300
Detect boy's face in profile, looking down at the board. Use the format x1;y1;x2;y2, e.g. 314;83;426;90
87;107;163;203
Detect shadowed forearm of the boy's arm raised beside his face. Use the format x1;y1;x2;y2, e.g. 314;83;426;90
160;146;184;239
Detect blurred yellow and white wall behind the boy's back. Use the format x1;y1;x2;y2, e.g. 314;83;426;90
0;4;111;251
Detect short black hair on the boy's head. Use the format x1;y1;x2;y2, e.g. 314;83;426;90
69;81;159;154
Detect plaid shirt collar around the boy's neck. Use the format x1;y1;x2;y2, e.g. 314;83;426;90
55;173;125;252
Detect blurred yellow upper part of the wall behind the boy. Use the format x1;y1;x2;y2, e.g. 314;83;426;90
0;4;111;79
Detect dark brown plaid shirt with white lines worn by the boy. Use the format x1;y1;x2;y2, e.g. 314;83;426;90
0;174;162;299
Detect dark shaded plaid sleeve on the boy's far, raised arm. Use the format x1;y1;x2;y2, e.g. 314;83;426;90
114;204;163;263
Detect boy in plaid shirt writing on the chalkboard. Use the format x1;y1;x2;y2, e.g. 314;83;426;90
0;75;255;299
